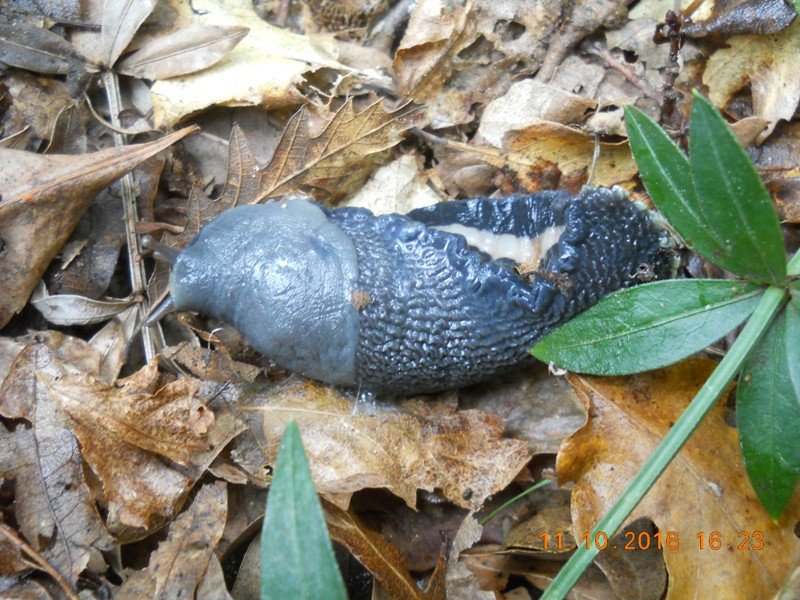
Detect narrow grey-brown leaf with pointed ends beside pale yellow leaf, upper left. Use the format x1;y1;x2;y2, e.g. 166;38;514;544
115;25;250;79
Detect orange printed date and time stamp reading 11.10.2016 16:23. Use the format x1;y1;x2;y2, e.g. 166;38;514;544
538;531;764;552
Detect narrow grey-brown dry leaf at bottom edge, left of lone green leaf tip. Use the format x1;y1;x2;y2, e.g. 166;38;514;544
115;481;228;600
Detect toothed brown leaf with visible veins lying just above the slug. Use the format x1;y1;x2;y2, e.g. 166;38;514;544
258;100;420;200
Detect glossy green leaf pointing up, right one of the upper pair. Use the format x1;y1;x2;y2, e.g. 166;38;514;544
689;92;786;285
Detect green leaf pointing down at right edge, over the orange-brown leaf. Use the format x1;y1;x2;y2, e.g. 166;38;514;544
736;303;800;520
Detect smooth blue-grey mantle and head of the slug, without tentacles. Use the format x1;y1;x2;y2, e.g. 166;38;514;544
170;200;359;385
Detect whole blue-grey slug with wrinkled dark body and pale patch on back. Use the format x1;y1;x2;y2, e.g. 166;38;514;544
146;187;673;396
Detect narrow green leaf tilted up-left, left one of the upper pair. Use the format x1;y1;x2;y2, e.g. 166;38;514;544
625;106;725;270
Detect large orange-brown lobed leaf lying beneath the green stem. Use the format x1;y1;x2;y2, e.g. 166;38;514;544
557;359;800;598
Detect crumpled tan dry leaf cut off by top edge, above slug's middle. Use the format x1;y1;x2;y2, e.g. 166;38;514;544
394;0;563;128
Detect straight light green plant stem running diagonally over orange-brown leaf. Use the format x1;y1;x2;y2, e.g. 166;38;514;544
542;276;800;600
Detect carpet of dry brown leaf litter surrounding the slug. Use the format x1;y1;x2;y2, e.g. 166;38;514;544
0;0;800;598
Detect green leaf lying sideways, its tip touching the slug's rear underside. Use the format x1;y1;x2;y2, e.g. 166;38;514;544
531;279;763;375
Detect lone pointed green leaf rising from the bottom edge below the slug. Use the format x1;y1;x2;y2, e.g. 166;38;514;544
261;421;347;600
